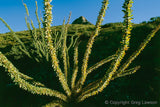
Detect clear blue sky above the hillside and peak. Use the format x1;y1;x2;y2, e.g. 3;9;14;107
0;0;160;33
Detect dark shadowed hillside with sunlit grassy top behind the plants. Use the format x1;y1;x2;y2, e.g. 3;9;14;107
0;23;160;107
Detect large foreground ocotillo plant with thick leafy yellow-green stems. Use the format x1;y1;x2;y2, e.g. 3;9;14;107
0;0;160;107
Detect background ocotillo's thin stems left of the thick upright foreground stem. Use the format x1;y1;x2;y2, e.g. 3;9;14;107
0;2;48;62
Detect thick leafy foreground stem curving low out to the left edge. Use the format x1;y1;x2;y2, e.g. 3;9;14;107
0;52;67;101
